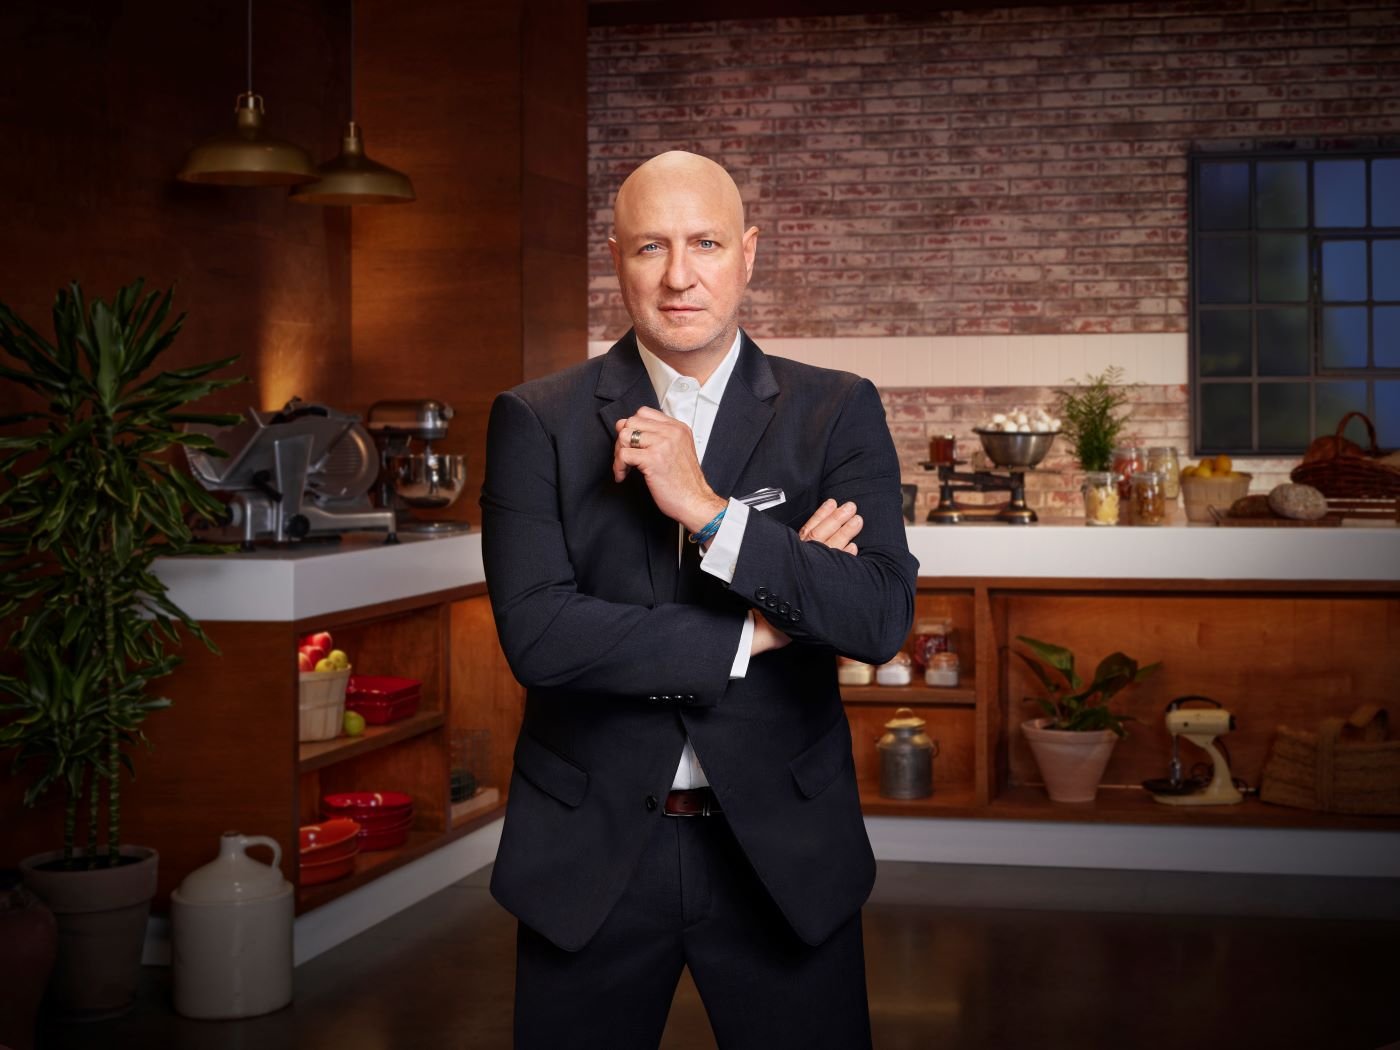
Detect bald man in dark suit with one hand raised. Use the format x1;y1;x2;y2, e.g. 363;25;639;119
482;153;917;1050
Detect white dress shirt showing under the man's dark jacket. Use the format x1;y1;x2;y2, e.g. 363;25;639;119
637;333;753;791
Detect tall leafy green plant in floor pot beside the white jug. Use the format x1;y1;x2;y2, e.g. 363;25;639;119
0;280;241;1016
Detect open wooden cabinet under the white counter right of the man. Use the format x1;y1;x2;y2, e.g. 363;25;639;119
843;577;1400;830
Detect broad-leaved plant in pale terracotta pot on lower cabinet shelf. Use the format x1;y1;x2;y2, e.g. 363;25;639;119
1016;634;1162;802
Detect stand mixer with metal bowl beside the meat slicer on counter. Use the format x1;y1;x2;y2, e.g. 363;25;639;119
365;400;472;533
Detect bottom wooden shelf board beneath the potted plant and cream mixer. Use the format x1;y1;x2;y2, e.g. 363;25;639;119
976;785;1400;832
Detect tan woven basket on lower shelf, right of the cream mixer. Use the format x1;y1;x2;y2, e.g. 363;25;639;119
1259;704;1400;815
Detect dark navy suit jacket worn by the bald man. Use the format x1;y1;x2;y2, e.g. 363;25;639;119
482;333;917;951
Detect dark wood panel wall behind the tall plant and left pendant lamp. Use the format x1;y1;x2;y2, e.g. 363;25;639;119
0;0;350;422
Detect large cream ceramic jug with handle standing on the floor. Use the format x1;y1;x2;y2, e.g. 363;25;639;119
171;832;295;1019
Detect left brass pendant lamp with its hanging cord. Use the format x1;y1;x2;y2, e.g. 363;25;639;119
175;0;316;186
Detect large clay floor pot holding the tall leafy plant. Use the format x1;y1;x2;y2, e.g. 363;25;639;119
20;846;158;1021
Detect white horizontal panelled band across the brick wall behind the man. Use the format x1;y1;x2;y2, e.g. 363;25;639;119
588;332;1187;389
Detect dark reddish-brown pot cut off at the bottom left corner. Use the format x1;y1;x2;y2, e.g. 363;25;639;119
0;871;59;1050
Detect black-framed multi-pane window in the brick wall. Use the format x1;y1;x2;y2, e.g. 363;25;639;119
1190;153;1400;455
